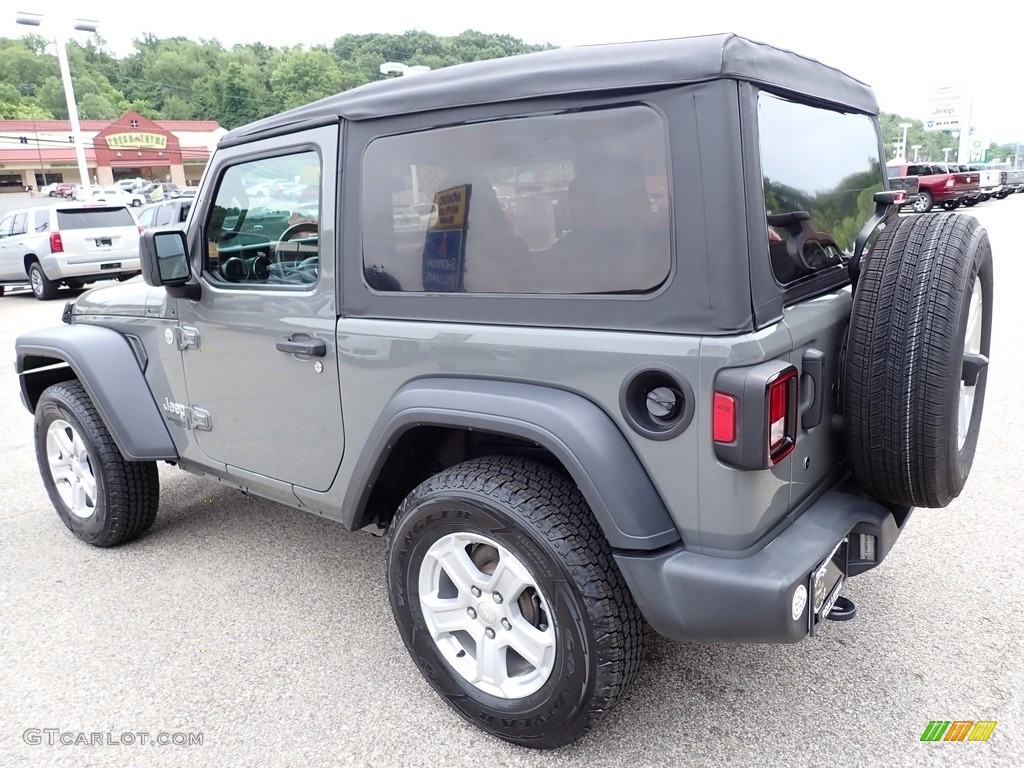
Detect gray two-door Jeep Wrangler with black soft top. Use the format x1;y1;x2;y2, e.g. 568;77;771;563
16;35;992;748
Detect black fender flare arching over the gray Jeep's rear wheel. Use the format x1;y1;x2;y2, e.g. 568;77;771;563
343;377;680;551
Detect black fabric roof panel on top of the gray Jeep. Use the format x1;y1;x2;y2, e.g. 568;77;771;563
220;34;879;145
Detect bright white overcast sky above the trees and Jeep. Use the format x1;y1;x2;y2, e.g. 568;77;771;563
0;0;1024;143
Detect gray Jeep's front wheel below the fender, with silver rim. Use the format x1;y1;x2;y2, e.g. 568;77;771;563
35;381;160;547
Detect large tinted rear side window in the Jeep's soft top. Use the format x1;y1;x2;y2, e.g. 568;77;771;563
361;104;671;294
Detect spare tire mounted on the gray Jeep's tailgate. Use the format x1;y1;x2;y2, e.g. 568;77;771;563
844;213;992;507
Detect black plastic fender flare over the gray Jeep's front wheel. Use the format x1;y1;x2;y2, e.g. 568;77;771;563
14;325;178;461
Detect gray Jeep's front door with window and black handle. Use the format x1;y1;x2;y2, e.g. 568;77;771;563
172;126;344;490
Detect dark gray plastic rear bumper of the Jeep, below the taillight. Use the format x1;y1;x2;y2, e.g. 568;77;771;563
615;490;909;643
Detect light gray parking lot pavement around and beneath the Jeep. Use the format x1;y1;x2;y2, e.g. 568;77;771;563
0;195;1024;767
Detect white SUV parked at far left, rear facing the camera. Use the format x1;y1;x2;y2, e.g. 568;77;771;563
0;204;139;300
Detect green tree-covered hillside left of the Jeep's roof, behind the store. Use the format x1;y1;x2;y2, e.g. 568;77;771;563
0;30;551;128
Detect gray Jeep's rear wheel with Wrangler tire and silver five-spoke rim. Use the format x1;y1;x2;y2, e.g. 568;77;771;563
387;457;644;749
